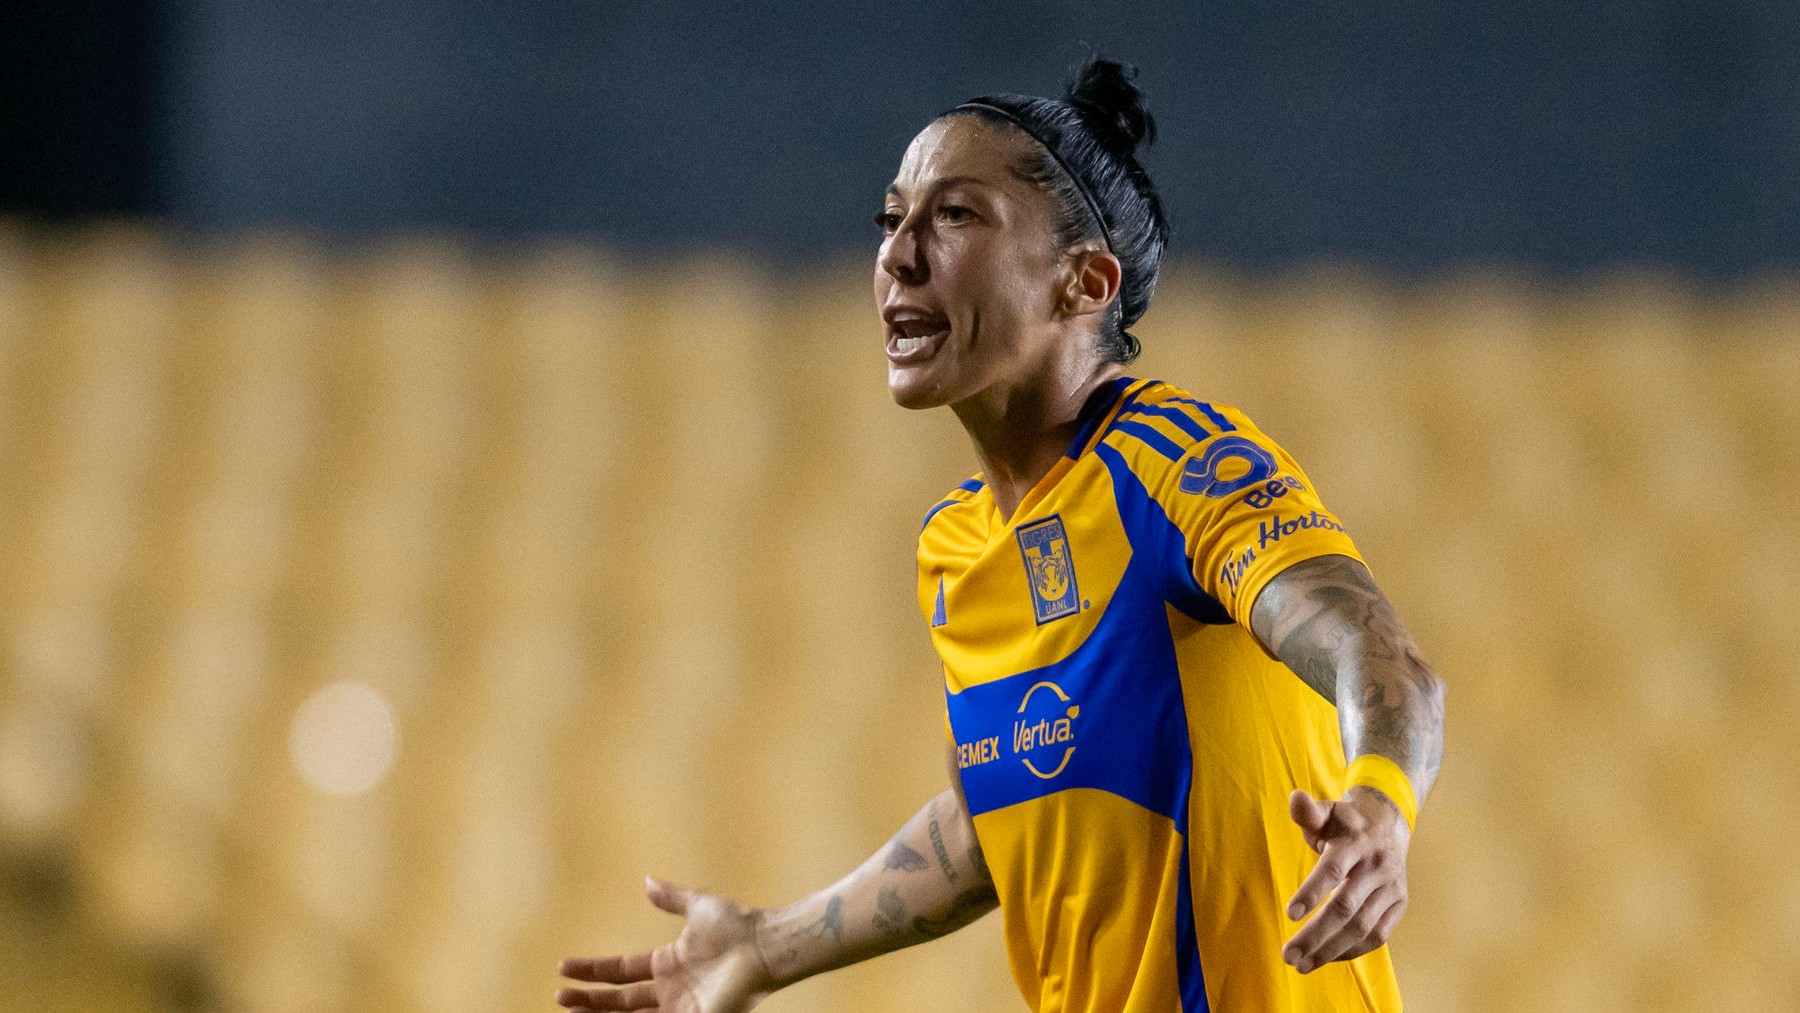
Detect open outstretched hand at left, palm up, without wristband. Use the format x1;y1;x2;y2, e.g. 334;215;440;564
556;878;774;1013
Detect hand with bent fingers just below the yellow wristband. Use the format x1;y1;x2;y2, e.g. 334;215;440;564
1282;786;1413;973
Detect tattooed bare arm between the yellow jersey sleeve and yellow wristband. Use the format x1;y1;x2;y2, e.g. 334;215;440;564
1251;556;1444;801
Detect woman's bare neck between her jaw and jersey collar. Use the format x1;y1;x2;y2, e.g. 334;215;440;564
952;362;1123;520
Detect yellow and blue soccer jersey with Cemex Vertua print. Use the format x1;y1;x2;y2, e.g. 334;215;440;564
918;380;1400;1013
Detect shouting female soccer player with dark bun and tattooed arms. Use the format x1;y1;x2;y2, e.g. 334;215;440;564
556;61;1444;1013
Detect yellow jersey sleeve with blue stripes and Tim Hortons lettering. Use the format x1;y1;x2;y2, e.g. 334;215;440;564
1159;405;1363;626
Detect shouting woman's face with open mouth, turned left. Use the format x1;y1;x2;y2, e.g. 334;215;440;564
875;115;1067;408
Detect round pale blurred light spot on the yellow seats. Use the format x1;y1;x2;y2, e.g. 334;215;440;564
288;682;394;795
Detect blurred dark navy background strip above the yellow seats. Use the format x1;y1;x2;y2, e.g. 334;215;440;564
0;0;1800;277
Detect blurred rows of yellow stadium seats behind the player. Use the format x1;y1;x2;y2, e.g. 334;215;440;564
0;229;1800;1013
